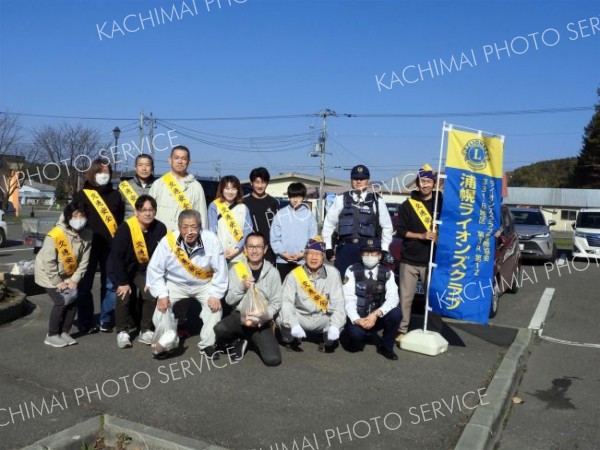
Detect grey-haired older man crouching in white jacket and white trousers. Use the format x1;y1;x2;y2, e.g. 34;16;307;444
146;210;228;359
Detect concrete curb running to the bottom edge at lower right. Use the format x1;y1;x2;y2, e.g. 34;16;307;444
454;329;533;450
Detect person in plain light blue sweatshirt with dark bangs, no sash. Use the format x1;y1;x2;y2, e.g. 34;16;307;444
271;183;317;282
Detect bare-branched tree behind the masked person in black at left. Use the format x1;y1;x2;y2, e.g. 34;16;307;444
34;124;102;195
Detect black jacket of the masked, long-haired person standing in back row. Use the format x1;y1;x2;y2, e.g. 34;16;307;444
73;181;125;249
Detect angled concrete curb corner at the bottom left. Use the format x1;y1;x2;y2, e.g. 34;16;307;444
22;415;227;450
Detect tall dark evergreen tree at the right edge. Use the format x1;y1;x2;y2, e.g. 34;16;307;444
571;89;600;189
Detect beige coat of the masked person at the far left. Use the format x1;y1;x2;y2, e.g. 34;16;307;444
35;221;92;288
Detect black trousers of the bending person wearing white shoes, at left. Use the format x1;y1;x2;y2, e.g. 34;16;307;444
115;272;156;333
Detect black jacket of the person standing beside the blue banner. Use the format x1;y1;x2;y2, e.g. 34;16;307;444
396;191;442;266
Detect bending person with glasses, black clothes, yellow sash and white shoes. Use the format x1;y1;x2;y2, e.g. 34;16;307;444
107;194;167;348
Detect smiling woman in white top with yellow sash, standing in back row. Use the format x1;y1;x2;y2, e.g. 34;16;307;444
208;175;252;264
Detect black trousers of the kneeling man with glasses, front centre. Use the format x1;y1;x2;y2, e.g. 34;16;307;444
215;310;281;366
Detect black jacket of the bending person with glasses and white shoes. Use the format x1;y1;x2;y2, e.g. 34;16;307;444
107;220;167;286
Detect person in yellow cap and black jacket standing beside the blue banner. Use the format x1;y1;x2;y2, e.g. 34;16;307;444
396;164;442;345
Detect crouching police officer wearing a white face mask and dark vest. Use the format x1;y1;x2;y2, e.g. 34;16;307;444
344;239;402;361
